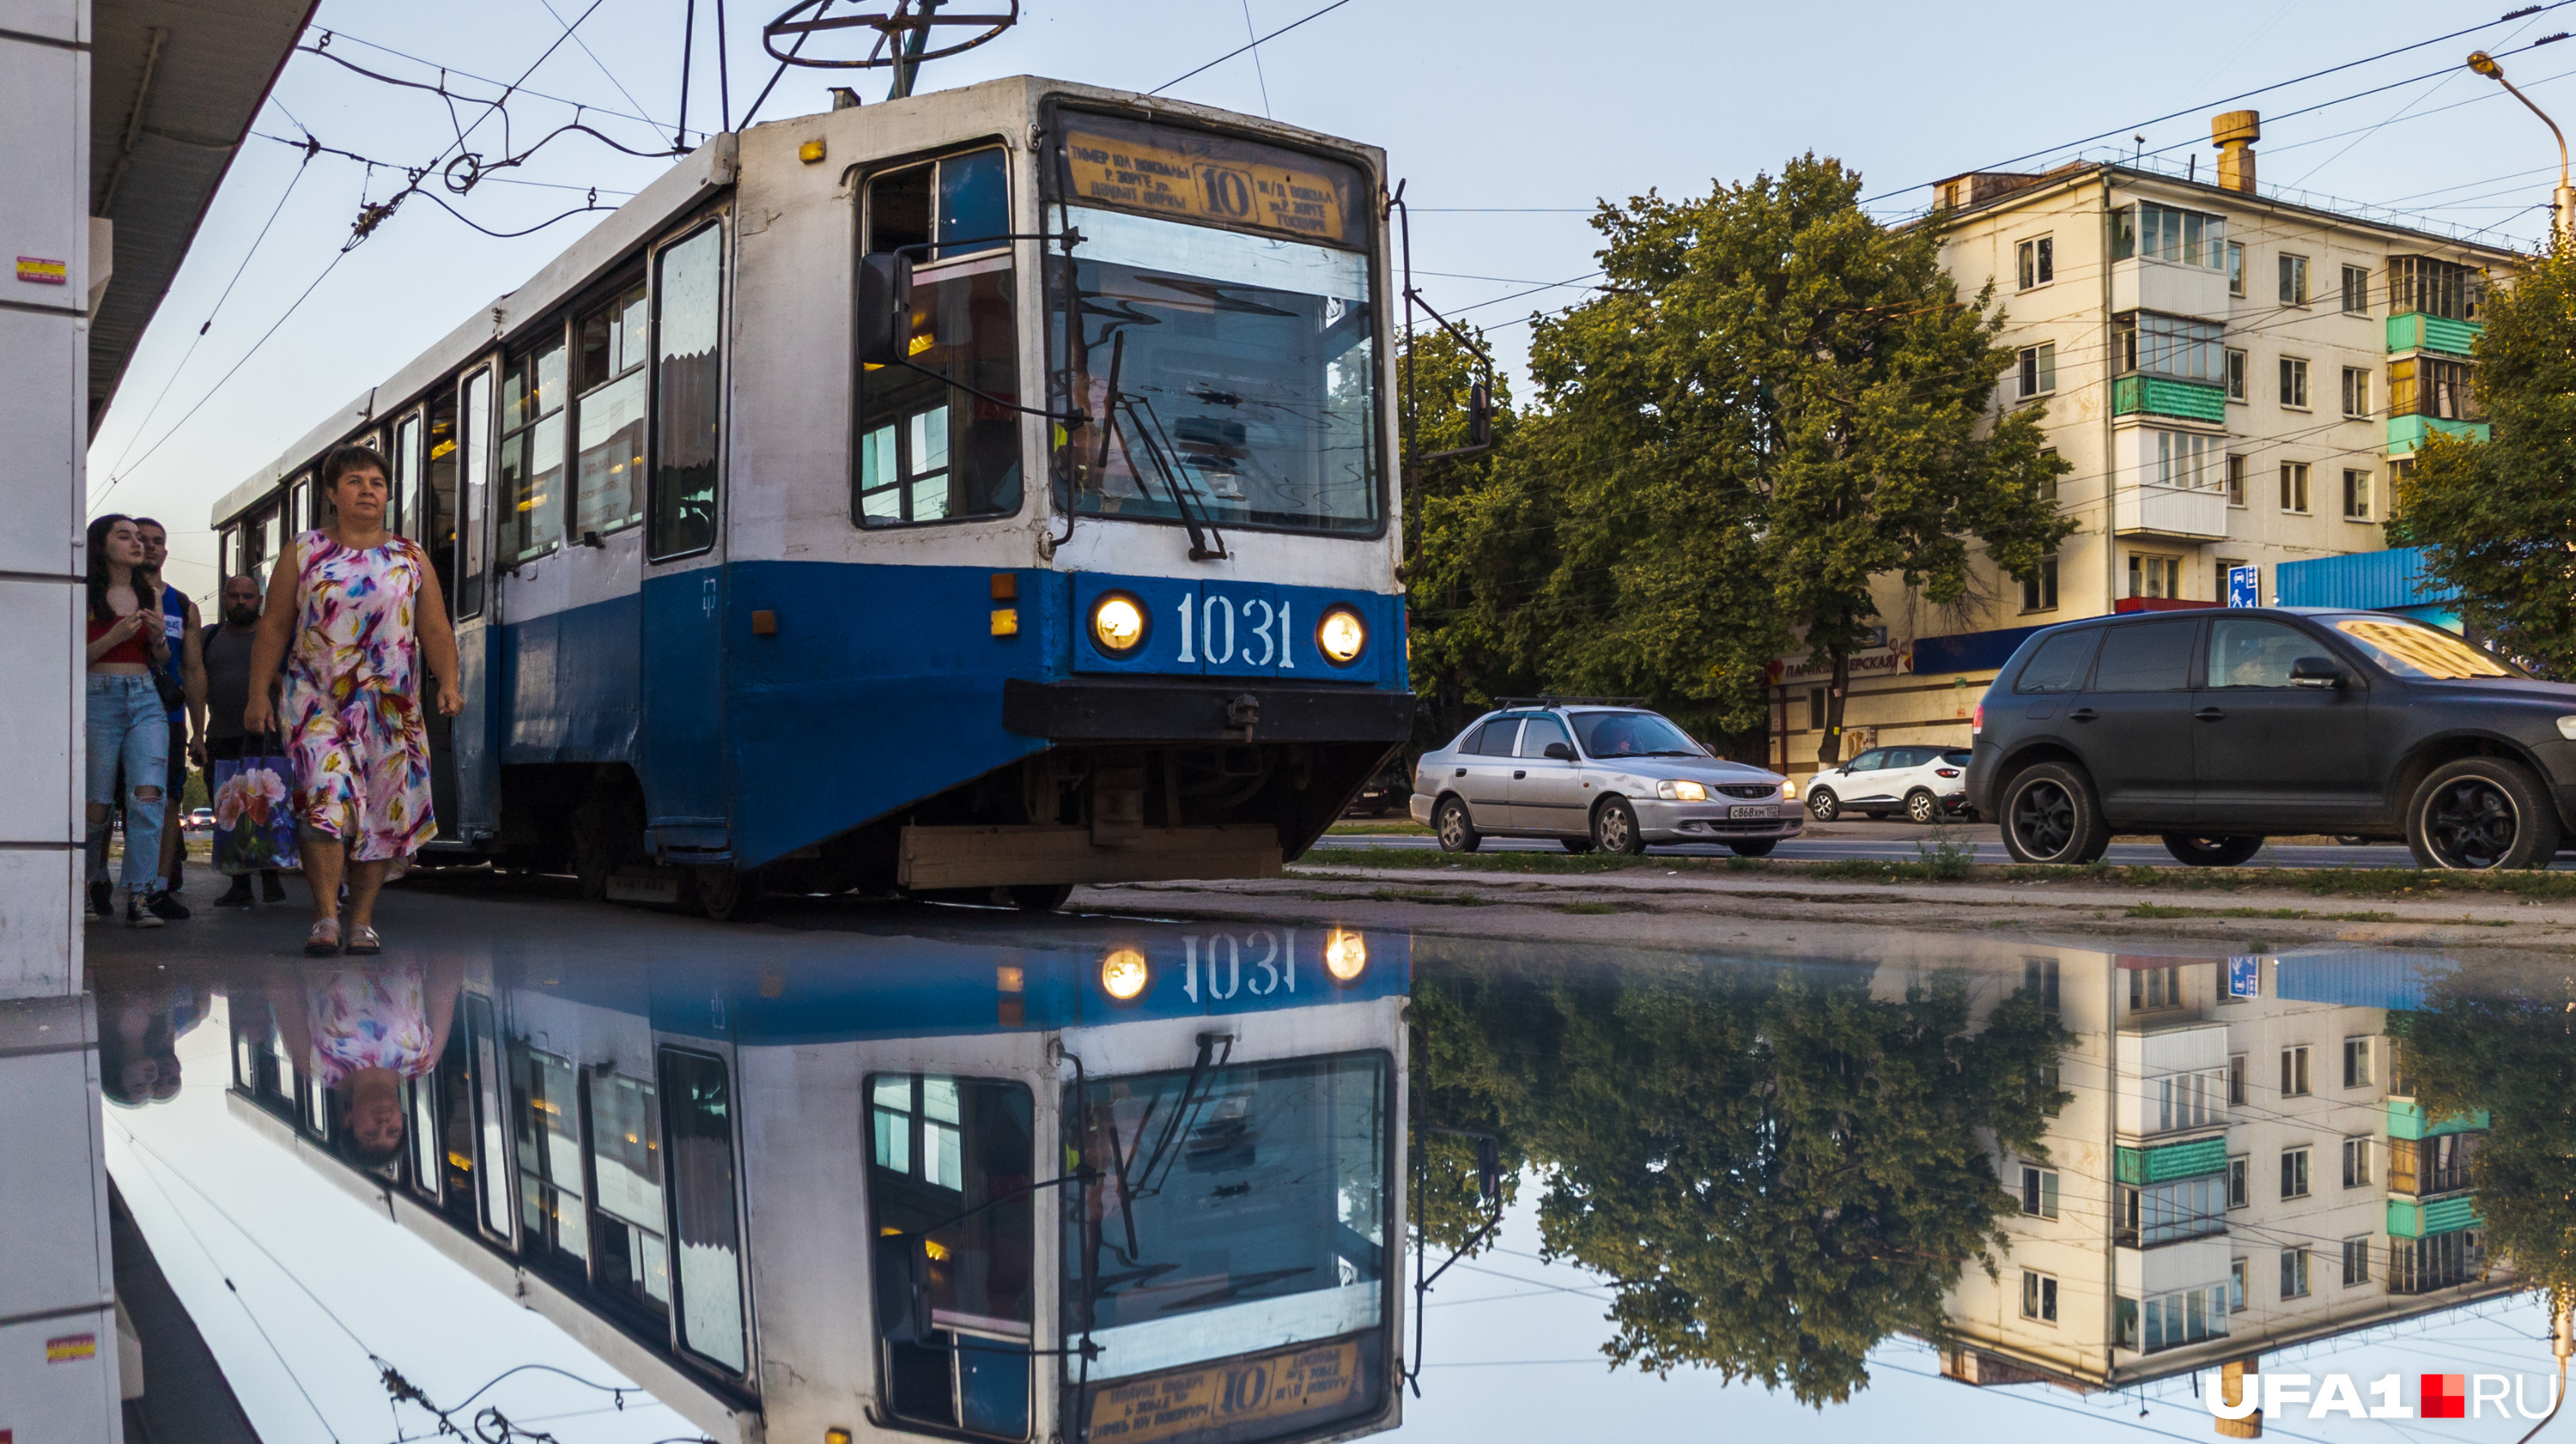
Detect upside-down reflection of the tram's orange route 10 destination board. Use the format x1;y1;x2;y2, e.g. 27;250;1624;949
1090;1338;1363;1444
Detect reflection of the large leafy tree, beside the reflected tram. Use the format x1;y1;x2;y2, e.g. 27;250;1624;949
1412;955;2069;1405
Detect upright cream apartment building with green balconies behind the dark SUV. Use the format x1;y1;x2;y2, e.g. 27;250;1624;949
1772;111;2514;774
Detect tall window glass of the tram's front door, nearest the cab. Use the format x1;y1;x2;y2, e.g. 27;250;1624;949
644;224;724;559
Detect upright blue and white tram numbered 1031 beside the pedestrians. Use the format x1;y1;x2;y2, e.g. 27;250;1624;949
214;77;1412;916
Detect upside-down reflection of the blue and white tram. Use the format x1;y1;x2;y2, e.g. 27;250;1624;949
232;921;1409;1444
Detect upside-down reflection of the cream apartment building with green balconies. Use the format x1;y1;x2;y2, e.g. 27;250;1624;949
1942;947;2517;1390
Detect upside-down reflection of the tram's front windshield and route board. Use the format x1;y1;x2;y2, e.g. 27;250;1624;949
1064;1055;1388;1439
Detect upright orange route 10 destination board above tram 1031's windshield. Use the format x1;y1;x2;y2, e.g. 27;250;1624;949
1064;116;1360;245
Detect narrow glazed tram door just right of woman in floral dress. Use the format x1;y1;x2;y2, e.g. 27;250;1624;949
448;361;500;841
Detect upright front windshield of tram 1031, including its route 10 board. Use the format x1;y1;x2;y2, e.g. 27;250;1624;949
1048;116;1381;533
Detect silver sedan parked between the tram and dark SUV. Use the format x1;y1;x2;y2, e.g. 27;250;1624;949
1412;706;1806;857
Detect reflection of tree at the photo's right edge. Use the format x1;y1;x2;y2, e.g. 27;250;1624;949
2388;970;2576;1313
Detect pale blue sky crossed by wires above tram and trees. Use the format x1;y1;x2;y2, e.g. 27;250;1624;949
90;0;2576;595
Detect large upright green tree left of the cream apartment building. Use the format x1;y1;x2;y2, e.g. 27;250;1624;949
1530;155;2074;761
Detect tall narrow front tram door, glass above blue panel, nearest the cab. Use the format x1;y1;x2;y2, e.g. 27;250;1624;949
636;216;729;844
